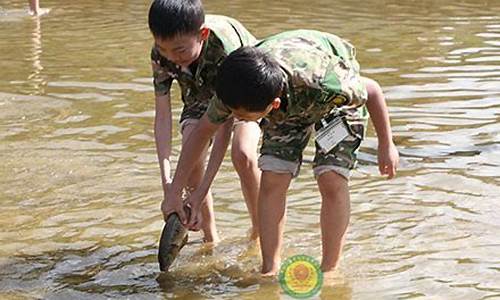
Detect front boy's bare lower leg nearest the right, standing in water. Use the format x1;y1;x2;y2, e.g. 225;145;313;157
318;171;350;272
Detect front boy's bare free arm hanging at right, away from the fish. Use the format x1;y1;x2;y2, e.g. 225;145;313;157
362;77;399;178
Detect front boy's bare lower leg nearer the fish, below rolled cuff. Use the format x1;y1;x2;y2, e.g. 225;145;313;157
258;171;292;276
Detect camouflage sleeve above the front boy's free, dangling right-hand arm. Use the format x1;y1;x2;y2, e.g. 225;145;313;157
323;40;368;107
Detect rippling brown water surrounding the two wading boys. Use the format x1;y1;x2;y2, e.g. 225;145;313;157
0;0;500;299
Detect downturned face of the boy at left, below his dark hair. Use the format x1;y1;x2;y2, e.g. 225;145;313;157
154;27;210;68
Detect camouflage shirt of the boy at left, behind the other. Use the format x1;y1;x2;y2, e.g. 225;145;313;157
151;15;256;122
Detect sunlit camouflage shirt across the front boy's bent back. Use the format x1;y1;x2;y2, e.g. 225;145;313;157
258;30;363;107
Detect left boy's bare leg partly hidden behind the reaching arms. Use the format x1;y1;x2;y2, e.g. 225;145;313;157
182;124;219;243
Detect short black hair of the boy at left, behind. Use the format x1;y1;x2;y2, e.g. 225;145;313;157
148;0;205;39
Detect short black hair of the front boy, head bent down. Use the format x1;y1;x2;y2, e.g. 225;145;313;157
215;46;284;112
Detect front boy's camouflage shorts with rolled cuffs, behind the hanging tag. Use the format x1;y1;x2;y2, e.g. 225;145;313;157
259;108;367;178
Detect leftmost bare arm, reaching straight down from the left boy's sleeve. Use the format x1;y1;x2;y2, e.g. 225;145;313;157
154;92;172;193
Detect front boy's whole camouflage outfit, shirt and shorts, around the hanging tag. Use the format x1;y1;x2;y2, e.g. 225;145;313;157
208;30;368;169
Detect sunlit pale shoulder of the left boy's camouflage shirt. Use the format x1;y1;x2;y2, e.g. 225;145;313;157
205;15;256;54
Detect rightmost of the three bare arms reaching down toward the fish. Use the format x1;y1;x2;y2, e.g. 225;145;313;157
187;118;233;228
